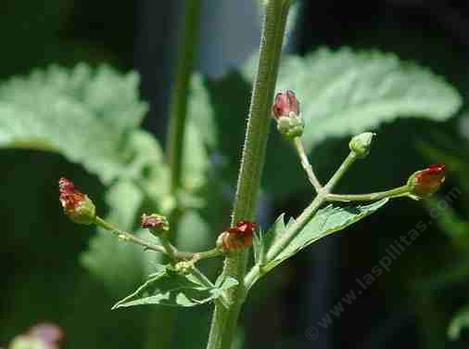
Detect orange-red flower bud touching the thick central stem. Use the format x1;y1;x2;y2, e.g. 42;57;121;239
217;221;257;251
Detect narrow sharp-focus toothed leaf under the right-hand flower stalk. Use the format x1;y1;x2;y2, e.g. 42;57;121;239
263;199;388;271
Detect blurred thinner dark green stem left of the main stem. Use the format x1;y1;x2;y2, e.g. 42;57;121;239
167;0;201;195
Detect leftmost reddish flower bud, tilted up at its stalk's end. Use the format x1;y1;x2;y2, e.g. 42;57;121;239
59;177;96;224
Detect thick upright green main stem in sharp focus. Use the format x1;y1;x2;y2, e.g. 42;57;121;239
207;0;290;349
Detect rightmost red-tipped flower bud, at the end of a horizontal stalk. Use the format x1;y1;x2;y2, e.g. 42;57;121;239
407;164;446;197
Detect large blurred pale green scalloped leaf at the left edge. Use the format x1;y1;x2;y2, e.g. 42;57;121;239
0;64;147;184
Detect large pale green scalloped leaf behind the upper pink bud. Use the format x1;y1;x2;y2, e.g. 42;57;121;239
246;48;462;150
